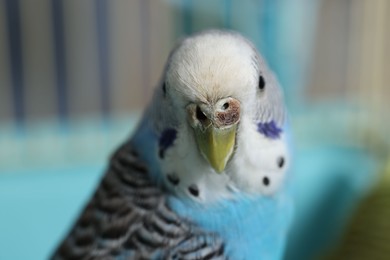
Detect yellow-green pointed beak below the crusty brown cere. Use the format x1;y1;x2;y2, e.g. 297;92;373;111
195;125;237;173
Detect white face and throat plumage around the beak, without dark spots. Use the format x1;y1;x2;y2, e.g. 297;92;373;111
152;31;289;203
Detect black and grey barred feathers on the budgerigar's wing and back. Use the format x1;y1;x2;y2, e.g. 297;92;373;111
52;143;225;259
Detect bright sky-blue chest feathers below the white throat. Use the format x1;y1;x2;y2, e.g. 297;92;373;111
168;192;292;259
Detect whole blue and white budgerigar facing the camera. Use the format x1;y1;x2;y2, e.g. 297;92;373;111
53;30;292;260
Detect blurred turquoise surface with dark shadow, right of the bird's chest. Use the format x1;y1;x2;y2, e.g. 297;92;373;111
285;145;379;260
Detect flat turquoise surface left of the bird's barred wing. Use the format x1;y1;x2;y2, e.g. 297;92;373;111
0;165;103;260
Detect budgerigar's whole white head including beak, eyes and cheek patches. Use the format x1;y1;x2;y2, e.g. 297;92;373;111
145;30;286;201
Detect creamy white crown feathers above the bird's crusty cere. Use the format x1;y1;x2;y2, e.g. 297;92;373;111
166;33;258;109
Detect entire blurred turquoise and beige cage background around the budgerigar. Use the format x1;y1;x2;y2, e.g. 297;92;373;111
0;0;390;259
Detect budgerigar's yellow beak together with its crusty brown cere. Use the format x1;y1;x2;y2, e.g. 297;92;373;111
187;97;240;173
